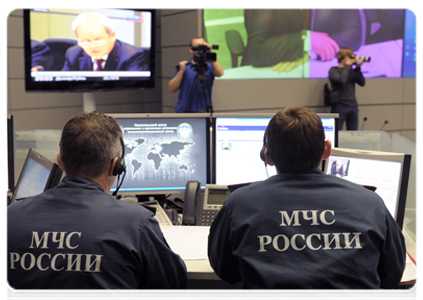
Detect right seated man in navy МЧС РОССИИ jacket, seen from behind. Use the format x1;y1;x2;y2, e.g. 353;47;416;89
208;106;406;300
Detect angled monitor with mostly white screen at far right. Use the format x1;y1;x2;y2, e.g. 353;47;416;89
324;148;411;227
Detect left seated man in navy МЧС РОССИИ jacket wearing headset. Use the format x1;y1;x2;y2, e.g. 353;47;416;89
5;112;187;300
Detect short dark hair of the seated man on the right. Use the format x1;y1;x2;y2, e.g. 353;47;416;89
265;106;325;173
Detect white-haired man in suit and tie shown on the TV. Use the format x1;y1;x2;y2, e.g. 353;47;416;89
62;12;148;71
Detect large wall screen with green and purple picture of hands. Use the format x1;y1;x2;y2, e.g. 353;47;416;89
203;8;420;80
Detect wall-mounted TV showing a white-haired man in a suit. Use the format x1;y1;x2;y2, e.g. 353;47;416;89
24;8;155;92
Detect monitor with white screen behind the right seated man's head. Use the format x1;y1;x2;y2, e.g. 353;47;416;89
212;113;338;185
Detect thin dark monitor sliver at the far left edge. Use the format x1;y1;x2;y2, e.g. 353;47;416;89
3;115;15;193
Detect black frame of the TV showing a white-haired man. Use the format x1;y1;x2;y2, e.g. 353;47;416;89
23;8;157;93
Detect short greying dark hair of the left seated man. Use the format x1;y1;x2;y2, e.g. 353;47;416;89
60;112;122;179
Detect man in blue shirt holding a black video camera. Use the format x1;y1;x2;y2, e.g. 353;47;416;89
169;37;224;113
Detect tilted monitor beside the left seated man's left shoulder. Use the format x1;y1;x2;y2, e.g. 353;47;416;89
12;148;63;203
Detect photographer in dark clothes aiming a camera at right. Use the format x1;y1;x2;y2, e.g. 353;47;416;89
329;47;366;130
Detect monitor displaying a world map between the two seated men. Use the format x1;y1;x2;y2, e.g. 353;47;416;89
111;113;210;196
